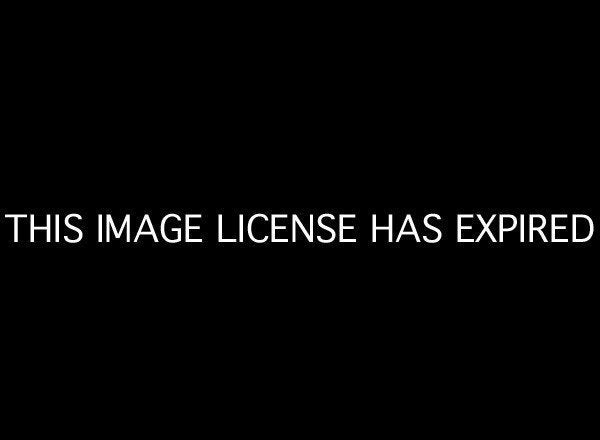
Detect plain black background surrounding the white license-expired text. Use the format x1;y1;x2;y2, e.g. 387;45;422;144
1;5;598;433
